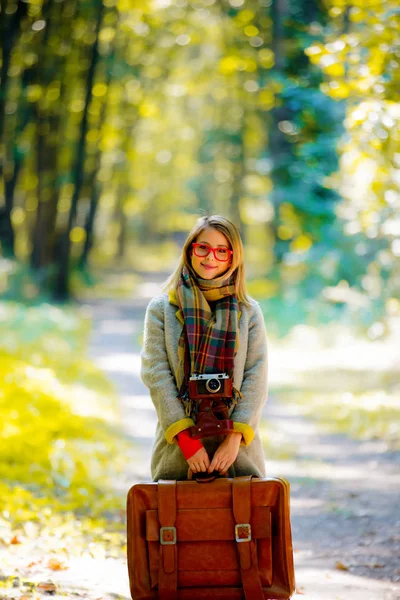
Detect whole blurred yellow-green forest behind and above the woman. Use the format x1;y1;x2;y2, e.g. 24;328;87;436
0;0;400;328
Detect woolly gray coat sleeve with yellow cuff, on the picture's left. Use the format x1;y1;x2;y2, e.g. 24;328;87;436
140;295;194;444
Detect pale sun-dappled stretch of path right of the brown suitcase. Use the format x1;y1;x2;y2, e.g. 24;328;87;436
267;394;400;600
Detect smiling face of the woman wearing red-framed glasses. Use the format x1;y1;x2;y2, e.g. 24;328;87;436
190;227;232;279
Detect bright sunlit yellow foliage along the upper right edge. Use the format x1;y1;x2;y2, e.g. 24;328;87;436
305;0;400;315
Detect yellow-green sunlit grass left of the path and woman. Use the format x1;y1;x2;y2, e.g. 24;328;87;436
0;302;130;525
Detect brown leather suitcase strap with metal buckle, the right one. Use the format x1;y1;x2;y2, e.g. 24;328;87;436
232;475;264;600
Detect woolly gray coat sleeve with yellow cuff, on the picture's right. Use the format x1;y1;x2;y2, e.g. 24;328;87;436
231;303;268;446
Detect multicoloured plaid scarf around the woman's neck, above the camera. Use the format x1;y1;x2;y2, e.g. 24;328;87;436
176;267;239;410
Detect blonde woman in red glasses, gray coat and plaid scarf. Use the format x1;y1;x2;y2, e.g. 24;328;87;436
141;215;268;481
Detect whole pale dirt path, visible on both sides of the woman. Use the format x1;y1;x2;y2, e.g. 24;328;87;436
83;276;400;600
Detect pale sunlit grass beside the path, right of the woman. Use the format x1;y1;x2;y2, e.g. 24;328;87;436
269;323;400;449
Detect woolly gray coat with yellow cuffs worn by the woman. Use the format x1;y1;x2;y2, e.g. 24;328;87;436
140;294;268;481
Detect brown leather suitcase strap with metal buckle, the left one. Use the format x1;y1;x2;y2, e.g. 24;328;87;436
157;479;178;600
